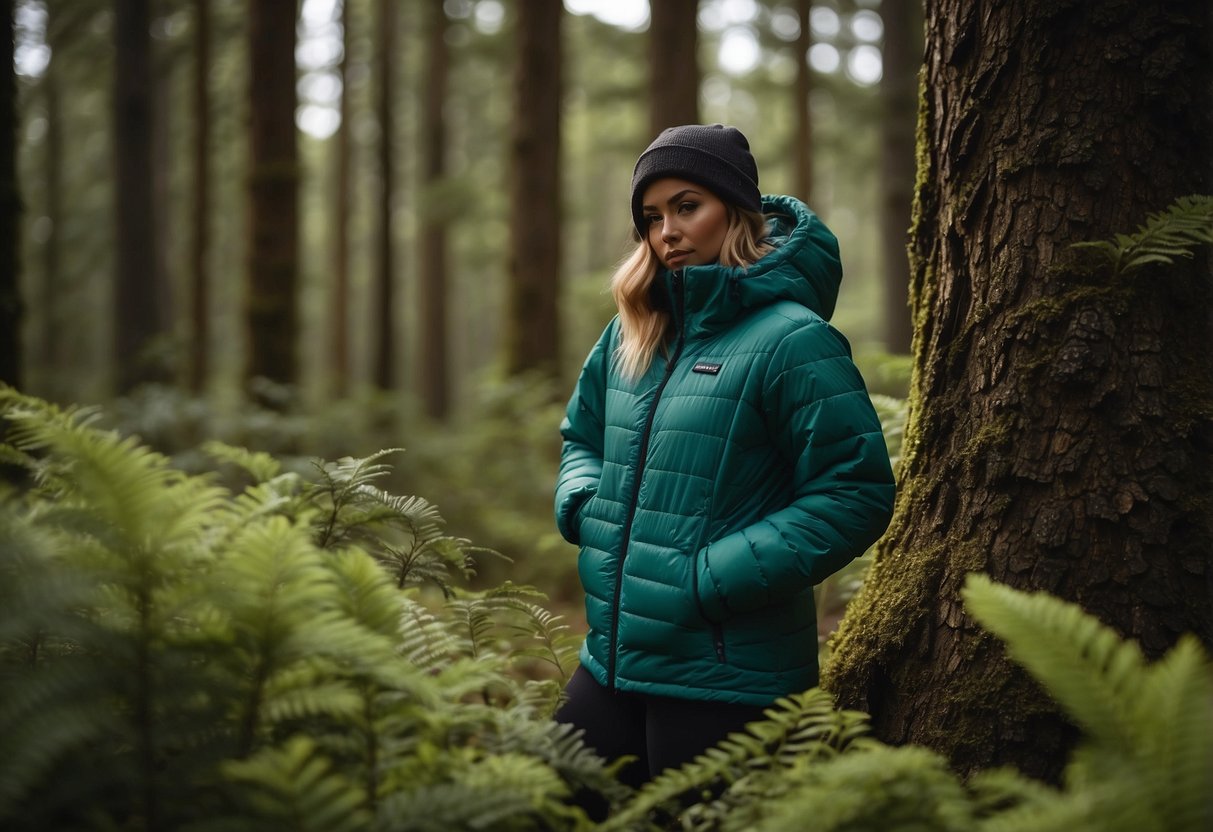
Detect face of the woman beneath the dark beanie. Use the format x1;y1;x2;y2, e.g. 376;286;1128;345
642;178;729;269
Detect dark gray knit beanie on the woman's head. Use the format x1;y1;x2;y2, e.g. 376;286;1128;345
632;124;762;238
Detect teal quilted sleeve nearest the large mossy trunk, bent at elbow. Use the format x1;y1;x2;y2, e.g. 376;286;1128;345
696;320;894;621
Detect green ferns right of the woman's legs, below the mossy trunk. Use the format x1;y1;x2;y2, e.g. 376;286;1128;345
602;576;1213;832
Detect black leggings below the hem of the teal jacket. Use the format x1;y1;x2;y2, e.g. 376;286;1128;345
556;667;765;787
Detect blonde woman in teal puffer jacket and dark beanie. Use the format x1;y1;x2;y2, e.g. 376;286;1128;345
556;124;893;785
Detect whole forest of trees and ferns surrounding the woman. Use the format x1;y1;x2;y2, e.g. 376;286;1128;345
0;0;1213;832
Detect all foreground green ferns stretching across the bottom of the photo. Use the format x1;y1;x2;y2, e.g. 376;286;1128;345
0;389;1213;832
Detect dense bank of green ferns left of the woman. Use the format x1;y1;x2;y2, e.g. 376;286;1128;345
0;389;611;830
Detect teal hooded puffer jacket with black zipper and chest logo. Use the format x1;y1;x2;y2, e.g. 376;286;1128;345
556;196;893;705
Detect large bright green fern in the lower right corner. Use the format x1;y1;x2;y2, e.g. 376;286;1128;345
963;575;1213;832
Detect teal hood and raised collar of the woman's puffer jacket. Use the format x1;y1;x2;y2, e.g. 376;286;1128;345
654;196;842;337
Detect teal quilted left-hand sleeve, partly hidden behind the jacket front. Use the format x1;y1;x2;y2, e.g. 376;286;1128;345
556;321;615;543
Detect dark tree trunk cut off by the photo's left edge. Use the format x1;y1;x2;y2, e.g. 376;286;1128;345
0;0;23;387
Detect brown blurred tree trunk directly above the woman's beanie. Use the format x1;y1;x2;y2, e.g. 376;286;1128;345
650;0;699;136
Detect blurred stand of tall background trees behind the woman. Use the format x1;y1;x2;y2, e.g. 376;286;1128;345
5;0;902;414
